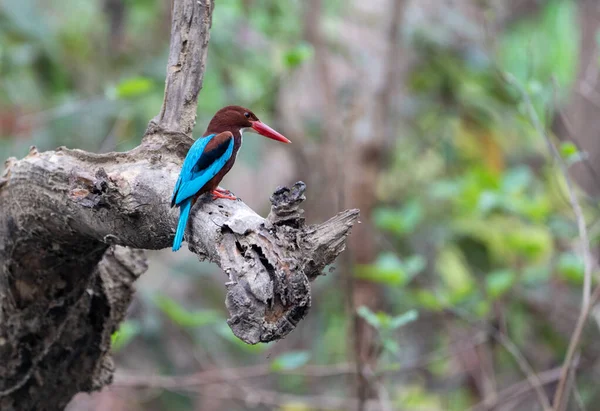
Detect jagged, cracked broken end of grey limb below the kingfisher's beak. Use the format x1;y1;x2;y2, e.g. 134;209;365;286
185;182;358;344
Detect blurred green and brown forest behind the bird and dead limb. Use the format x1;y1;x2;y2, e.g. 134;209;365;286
0;0;600;411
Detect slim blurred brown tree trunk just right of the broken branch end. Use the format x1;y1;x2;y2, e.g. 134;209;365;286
346;0;408;404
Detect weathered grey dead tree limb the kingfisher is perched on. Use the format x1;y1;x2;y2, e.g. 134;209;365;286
0;0;358;410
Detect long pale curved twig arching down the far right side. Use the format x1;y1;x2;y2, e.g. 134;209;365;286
505;74;593;411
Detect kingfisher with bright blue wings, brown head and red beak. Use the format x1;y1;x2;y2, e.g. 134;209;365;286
171;106;291;251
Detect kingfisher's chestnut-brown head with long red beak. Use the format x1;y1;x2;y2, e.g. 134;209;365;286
206;106;291;143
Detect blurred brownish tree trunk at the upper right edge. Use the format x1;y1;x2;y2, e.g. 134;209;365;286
554;0;600;196
